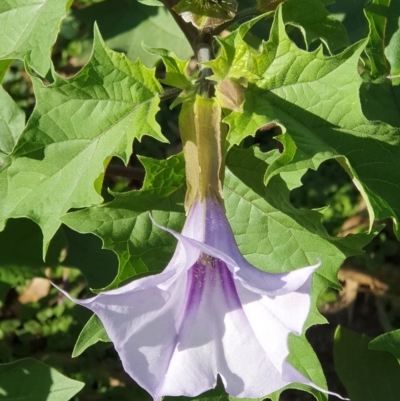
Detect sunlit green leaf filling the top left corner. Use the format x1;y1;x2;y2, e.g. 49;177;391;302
0;0;72;76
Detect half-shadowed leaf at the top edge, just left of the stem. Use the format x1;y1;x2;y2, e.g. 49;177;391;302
75;0;193;67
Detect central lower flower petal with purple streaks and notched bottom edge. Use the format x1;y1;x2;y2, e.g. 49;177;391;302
155;261;287;398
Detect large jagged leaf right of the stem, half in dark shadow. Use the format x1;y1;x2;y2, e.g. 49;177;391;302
226;7;400;237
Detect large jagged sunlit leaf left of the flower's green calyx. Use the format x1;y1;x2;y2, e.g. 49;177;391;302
0;26;165;249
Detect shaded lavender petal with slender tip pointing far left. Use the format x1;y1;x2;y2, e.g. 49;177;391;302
57;274;189;397
